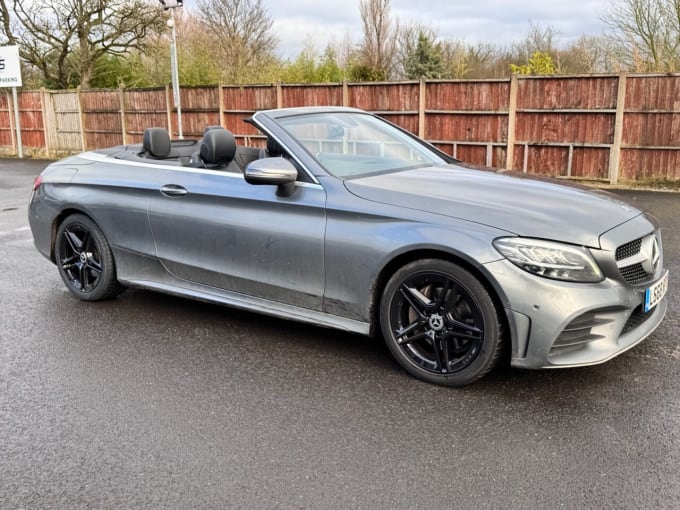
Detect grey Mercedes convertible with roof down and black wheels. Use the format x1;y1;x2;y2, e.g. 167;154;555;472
29;107;668;386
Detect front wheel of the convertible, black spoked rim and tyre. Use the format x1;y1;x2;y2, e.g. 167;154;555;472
380;259;503;386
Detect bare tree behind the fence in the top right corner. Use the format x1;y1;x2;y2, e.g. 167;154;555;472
602;0;680;72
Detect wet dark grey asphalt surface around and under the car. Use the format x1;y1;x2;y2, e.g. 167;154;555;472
0;160;680;509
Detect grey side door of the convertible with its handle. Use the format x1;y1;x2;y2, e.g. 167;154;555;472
148;167;326;310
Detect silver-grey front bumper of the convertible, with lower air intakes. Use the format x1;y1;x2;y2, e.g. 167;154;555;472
485;216;668;369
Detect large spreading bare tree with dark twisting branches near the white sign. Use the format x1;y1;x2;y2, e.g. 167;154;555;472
0;0;164;88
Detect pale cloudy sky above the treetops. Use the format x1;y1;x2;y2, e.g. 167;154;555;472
178;0;613;60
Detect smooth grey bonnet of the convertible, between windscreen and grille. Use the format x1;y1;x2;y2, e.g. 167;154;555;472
345;165;640;247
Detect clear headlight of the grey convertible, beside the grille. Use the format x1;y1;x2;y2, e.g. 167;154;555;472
493;237;604;283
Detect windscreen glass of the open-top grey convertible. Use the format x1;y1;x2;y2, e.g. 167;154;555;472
277;112;446;179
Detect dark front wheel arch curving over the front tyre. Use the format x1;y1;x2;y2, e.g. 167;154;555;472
369;248;511;342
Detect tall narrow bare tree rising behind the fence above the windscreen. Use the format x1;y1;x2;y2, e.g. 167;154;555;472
359;0;398;80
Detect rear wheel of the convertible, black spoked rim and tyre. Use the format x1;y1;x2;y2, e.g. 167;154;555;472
54;214;123;301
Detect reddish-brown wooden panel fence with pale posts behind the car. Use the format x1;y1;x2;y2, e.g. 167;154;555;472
0;73;680;184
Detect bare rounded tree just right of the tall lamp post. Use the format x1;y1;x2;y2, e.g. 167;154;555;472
198;0;278;83
